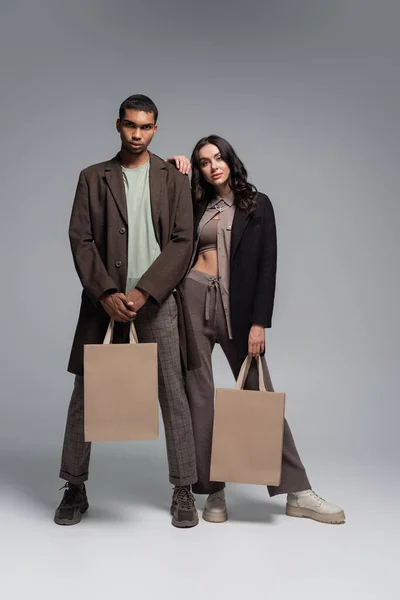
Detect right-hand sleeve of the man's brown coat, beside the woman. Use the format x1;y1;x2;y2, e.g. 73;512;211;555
136;176;193;305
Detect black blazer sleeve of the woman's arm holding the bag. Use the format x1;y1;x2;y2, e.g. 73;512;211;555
251;196;277;327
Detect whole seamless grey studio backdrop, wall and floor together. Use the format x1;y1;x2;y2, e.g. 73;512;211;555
0;0;400;600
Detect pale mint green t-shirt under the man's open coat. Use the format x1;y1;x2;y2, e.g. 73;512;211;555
122;161;160;293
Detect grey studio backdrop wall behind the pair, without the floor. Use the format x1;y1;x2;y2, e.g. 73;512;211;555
0;0;400;477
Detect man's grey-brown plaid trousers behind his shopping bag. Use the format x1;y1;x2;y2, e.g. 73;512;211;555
60;296;197;485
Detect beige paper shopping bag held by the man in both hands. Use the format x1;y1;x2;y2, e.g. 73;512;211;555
84;321;158;442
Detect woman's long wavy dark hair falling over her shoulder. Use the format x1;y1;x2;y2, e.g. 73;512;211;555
191;135;257;215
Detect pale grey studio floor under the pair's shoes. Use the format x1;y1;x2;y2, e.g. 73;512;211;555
0;440;400;600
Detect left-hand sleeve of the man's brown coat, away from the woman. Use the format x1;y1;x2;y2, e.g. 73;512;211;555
69;171;118;304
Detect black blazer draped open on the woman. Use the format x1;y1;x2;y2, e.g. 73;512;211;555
194;192;277;361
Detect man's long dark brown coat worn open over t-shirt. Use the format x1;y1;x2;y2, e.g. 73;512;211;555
68;154;199;375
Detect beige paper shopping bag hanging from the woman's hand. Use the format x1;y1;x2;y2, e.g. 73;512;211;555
210;357;285;485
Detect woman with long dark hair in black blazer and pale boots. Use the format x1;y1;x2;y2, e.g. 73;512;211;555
183;135;345;523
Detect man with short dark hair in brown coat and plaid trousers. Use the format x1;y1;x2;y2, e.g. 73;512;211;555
55;95;198;527
